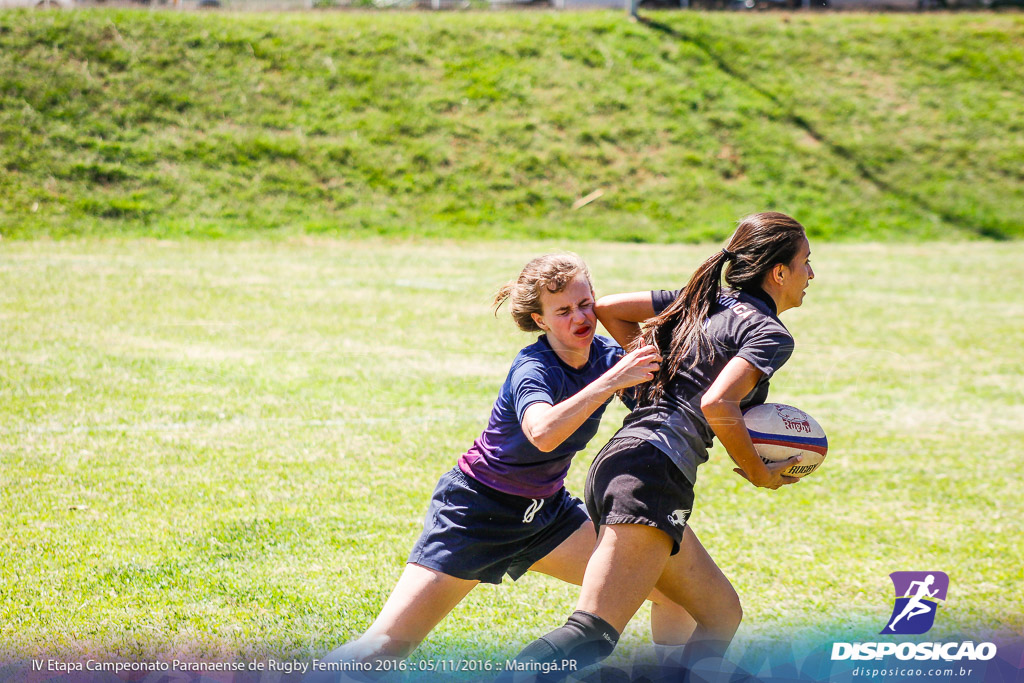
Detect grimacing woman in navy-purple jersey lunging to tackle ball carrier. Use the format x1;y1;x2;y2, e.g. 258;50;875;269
327;254;699;663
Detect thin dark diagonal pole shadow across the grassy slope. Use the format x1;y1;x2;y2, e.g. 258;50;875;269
637;15;1012;241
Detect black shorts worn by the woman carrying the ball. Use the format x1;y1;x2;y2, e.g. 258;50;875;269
586;437;693;555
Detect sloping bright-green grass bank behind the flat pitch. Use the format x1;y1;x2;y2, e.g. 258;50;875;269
0;10;1024;242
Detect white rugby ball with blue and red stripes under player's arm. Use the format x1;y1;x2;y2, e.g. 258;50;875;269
743;403;828;477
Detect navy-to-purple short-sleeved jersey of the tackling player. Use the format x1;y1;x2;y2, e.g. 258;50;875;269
459;336;623;498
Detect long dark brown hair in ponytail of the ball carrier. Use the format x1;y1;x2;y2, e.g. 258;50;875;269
630;212;805;405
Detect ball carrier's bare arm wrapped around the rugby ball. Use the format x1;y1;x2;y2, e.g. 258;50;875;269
700;356;801;488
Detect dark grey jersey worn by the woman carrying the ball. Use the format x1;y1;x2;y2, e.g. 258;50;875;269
615;289;794;483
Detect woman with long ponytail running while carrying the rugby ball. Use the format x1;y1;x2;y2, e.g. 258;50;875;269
518;213;814;680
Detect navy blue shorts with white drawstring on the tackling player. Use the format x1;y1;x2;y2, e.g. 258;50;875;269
409;467;589;584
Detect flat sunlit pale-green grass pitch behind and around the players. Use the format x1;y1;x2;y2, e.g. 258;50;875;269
0;239;1024;660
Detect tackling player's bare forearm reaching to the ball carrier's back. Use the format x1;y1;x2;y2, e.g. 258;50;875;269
522;346;662;453
